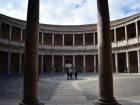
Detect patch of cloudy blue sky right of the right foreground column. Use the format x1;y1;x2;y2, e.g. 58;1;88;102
109;0;140;20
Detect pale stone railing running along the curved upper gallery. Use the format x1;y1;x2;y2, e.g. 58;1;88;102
0;37;140;51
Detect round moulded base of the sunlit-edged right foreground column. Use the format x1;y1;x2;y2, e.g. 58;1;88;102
95;98;121;105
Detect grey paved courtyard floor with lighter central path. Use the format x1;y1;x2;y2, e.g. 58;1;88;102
0;73;140;105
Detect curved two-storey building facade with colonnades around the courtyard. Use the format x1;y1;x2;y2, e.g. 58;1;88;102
0;13;140;75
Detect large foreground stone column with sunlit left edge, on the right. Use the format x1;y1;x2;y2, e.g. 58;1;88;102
96;0;118;105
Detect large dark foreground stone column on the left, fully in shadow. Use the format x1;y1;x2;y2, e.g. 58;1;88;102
20;0;43;105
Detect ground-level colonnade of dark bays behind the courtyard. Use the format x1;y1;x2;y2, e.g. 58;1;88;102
0;50;140;75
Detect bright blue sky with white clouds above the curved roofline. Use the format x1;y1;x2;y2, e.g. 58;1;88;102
0;0;140;25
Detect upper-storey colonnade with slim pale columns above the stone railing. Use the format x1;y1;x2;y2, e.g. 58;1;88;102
0;18;140;46
